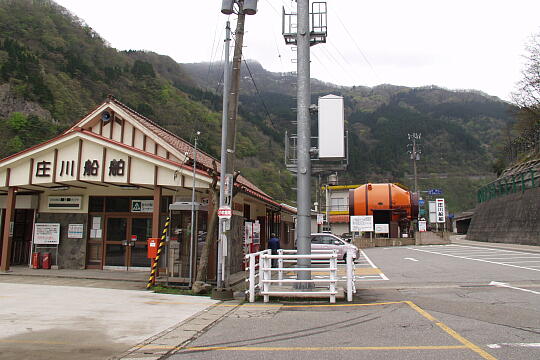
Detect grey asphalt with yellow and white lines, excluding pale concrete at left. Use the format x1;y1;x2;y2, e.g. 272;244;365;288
169;245;540;360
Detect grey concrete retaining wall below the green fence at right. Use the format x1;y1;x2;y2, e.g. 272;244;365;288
467;187;540;245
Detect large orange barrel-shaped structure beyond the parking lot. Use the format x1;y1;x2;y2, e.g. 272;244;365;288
349;183;418;235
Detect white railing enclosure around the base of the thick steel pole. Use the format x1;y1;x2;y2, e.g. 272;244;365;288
246;249;356;303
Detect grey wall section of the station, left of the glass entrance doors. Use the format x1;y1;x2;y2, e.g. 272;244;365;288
36;213;88;269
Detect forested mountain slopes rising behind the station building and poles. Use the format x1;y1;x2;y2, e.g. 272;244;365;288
0;0;513;211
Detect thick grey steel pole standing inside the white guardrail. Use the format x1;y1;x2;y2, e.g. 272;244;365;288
296;0;313;289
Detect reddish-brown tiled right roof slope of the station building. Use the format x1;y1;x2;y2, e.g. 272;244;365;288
109;96;277;200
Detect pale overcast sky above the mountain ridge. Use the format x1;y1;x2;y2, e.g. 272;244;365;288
55;0;540;100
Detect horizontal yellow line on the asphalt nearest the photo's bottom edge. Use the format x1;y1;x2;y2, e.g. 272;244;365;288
141;345;467;351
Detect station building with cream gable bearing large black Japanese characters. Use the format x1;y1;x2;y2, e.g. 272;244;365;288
0;97;294;277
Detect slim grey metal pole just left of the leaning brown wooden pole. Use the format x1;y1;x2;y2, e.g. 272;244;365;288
217;21;231;289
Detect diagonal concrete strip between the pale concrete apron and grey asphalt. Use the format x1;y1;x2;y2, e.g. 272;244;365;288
112;301;243;360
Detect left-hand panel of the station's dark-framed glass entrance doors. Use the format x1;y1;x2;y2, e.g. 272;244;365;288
105;217;129;266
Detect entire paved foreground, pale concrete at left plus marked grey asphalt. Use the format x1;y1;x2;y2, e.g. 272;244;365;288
0;245;540;360
